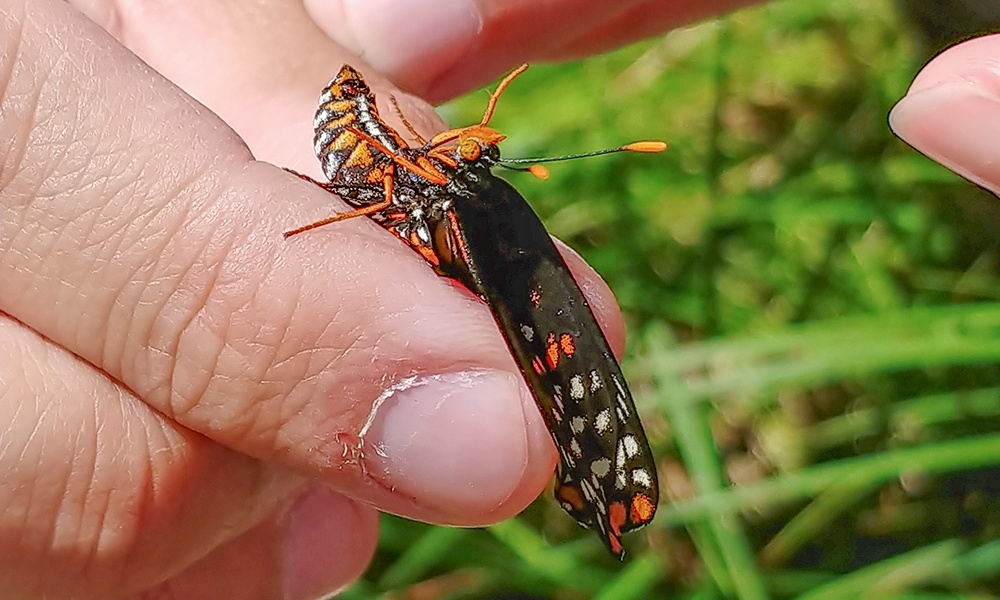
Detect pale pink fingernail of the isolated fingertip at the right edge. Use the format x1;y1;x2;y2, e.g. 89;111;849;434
889;74;1000;192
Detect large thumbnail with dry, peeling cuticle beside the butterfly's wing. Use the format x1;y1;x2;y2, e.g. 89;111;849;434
362;370;537;518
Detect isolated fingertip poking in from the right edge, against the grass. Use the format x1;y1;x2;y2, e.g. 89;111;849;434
889;35;1000;193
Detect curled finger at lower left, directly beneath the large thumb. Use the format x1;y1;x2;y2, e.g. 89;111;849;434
0;318;326;598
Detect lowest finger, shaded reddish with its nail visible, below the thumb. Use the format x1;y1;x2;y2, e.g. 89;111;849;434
132;488;378;600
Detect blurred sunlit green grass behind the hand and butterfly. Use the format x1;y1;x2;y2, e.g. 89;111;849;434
342;0;1000;600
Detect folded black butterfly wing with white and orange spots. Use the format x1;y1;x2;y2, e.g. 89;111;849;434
434;173;658;557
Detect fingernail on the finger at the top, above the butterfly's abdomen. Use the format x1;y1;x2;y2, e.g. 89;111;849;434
344;0;483;80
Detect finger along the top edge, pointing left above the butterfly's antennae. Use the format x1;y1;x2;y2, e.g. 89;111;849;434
303;0;748;102
